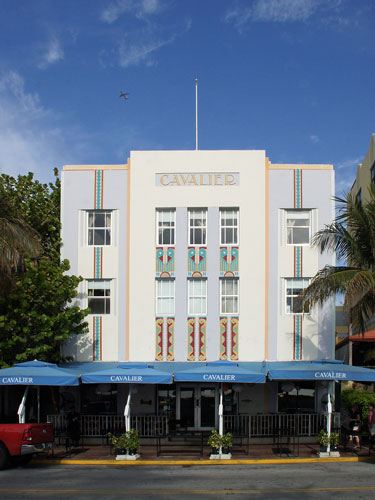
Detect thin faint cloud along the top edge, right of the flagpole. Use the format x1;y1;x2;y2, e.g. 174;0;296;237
224;0;342;31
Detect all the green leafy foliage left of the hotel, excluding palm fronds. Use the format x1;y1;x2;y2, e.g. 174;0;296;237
0;170;87;366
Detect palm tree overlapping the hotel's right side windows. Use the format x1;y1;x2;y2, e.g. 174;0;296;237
300;185;375;333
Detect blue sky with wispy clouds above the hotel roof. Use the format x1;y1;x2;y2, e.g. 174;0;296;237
0;0;375;194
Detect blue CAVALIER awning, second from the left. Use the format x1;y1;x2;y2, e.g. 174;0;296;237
81;363;172;384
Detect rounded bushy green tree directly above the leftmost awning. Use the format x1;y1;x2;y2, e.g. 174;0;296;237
0;258;87;367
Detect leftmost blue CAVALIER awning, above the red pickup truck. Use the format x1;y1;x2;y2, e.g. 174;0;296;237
0;360;79;385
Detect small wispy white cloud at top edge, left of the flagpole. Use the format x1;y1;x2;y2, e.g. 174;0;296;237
100;0;163;24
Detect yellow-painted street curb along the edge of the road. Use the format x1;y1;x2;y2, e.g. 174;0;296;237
31;457;375;467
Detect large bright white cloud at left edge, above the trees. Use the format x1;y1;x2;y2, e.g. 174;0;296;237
0;71;88;182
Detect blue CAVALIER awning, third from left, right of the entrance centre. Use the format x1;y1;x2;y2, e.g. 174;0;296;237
174;360;266;384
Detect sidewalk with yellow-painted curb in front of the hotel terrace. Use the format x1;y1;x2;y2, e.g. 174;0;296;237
33;444;375;466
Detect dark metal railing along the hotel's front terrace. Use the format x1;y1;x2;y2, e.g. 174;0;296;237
47;413;340;437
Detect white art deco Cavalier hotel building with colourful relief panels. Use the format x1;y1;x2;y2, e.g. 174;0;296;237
62;151;335;427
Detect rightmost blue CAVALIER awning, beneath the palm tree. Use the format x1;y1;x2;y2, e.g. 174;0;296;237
266;360;375;382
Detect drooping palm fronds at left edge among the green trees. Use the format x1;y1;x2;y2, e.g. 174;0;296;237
0;198;41;294
